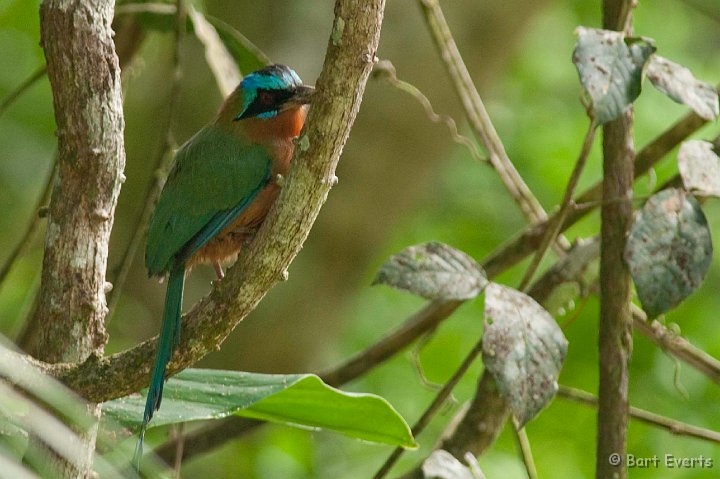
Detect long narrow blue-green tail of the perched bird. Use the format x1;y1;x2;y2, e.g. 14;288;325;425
133;263;185;470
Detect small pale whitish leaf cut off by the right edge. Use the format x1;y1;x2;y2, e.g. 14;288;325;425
678;140;720;196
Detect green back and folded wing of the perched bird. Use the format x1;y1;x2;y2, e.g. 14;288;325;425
145;125;271;275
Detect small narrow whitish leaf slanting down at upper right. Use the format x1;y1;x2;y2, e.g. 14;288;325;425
647;55;718;120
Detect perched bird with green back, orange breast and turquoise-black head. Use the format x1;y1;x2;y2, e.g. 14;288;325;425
135;65;314;467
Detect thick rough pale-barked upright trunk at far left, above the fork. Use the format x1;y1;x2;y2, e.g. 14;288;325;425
36;0;125;362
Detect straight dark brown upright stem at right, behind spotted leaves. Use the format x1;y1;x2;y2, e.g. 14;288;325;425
595;0;635;479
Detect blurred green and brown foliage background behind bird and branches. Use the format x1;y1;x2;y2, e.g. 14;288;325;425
0;0;720;479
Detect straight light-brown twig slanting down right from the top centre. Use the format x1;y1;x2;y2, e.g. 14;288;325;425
418;0;570;253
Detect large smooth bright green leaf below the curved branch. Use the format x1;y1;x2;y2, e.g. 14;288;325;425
103;369;416;448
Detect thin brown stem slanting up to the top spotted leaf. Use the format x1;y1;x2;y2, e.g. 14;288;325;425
518;119;597;291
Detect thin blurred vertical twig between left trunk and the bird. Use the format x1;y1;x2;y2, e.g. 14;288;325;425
106;0;187;322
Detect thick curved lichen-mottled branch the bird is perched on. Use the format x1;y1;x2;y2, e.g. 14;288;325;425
40;0;385;401
